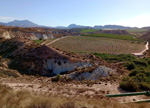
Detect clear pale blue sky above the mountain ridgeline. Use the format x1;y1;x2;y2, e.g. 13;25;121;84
0;0;150;27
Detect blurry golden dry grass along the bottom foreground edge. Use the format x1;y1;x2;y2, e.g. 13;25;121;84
0;85;149;108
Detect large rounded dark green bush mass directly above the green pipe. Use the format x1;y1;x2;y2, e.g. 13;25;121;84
120;68;150;91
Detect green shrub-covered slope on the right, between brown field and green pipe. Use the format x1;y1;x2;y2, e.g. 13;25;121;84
94;53;150;91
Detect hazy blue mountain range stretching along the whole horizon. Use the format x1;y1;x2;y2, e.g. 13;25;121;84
0;20;149;29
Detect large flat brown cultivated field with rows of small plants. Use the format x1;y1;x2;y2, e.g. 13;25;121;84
50;36;145;54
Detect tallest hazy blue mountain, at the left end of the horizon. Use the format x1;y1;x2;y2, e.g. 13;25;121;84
0;20;39;27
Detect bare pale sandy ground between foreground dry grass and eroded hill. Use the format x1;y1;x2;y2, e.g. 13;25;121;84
0;77;146;102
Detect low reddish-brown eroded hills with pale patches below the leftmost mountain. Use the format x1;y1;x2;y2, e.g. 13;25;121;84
0;25;81;40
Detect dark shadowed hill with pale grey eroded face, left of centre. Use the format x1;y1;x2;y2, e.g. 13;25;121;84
0;38;90;76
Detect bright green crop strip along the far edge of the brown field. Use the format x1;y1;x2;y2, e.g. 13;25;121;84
82;33;138;41
